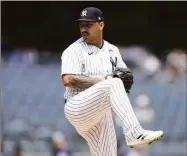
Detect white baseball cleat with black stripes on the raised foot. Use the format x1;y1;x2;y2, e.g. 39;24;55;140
127;131;164;148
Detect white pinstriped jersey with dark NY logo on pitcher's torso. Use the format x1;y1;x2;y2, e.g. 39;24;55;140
61;38;127;100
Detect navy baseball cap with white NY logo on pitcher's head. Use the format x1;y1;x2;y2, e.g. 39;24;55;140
76;7;104;22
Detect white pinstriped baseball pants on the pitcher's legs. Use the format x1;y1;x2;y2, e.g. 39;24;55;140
65;78;139;156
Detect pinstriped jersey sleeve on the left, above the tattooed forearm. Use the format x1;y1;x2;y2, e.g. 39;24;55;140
61;44;82;75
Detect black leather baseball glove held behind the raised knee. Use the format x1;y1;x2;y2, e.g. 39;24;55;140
112;68;134;93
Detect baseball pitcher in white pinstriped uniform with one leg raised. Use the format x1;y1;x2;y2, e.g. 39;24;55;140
61;7;163;156
